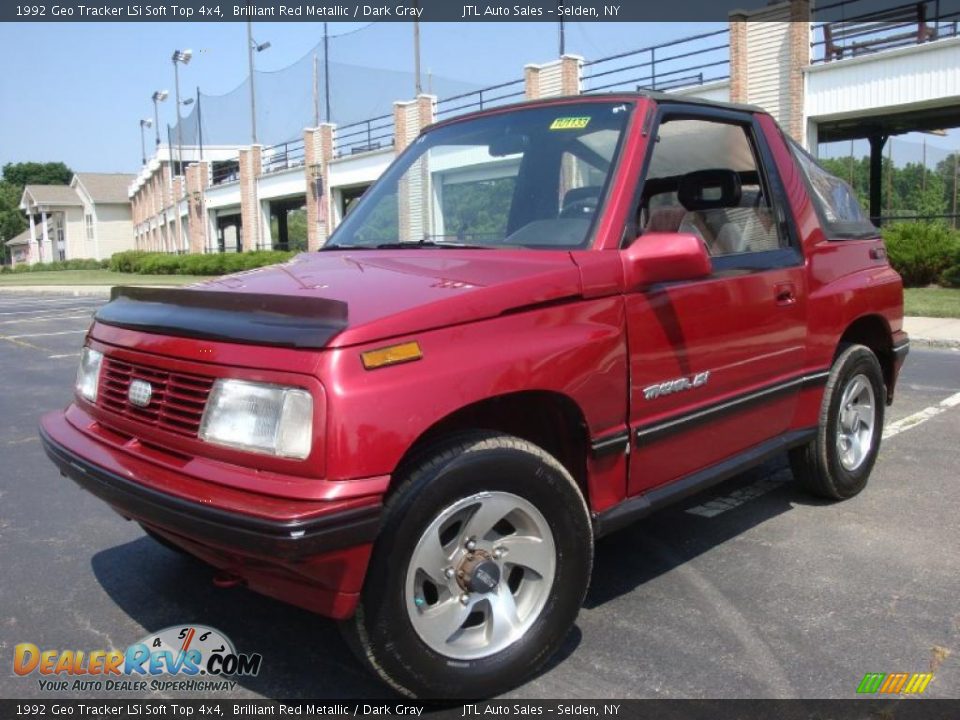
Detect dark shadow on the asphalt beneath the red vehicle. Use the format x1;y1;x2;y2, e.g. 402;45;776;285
91;458;806;699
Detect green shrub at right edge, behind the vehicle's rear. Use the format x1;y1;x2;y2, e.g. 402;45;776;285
883;222;960;287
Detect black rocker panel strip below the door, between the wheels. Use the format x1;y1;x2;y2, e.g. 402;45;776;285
593;427;817;537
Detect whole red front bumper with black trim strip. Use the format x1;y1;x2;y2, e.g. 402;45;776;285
40;411;382;618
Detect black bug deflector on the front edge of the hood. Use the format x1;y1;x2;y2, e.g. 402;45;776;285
94;286;347;348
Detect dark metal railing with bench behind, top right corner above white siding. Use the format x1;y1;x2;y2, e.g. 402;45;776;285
810;0;960;63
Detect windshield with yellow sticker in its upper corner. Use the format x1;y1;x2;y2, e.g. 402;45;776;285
326;102;630;249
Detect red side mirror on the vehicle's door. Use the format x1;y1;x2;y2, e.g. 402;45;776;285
621;233;713;290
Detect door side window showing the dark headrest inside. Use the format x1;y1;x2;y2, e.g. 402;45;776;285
640;119;787;257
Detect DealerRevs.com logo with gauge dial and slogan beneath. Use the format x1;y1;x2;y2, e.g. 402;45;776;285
13;625;263;692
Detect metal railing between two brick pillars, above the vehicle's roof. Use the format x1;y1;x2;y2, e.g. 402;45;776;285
583;28;730;92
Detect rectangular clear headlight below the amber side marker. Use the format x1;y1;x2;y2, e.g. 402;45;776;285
200;380;313;459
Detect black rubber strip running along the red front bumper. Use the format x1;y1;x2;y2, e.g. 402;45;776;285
40;428;382;560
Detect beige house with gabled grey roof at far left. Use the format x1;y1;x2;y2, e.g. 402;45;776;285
13;173;134;264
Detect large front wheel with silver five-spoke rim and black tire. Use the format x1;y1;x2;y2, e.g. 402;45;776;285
344;433;593;698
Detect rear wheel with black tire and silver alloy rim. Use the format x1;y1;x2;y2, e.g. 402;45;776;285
790;345;887;500
